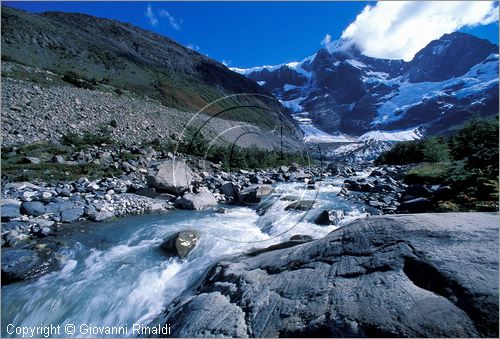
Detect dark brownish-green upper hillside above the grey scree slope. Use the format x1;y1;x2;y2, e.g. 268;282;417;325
2;6;301;140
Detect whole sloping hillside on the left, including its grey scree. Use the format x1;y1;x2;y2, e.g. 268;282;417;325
2;6;301;147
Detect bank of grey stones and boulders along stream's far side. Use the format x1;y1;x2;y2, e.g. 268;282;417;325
1;141;460;284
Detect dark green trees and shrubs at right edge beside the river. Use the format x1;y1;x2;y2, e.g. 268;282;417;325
375;117;499;210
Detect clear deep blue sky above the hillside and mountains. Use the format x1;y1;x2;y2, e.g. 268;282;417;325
4;2;498;67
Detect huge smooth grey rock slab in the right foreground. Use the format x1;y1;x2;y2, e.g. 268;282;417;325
150;213;499;337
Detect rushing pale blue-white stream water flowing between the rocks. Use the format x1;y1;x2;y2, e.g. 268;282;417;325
1;173;372;337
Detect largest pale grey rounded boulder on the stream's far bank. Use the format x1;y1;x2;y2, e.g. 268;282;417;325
146;159;193;195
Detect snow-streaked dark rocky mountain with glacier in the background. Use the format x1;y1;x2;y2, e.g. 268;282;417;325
234;33;498;138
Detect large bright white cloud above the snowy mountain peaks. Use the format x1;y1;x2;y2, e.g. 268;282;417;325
338;1;498;61
